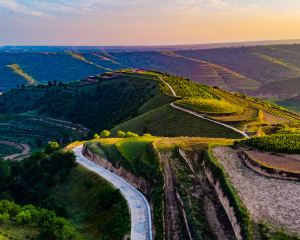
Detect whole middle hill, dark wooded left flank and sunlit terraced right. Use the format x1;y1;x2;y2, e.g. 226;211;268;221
0;70;300;155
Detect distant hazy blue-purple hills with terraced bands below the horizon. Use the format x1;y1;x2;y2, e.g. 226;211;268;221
0;44;300;111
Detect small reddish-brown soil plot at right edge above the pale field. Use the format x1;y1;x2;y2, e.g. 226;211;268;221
244;150;300;174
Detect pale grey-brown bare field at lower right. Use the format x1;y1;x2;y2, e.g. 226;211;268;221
213;147;300;234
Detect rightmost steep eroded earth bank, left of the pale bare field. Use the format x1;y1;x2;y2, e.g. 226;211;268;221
178;148;242;240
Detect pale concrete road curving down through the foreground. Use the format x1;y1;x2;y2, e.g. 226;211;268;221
73;145;152;240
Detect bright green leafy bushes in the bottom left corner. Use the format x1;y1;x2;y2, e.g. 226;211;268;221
0;200;81;240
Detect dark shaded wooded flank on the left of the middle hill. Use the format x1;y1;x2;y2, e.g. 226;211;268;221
0;74;159;130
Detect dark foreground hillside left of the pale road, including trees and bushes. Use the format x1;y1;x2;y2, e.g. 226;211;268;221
0;146;130;240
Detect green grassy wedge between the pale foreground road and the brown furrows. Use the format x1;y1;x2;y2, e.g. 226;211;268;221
86;136;164;240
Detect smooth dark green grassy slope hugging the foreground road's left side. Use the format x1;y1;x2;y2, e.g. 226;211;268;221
49;167;130;240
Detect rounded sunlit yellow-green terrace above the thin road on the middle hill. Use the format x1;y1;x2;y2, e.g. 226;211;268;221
176;98;243;114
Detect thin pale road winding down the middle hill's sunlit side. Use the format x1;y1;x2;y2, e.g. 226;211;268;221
158;76;250;138
